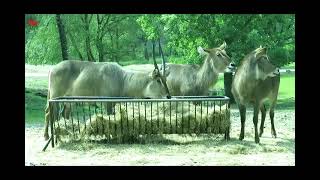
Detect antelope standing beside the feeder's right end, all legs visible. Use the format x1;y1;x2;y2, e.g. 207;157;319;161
231;46;280;143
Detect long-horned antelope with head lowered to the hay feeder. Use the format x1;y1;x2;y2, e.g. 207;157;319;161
44;60;170;140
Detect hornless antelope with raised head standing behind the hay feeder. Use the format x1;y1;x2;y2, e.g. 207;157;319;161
160;42;233;96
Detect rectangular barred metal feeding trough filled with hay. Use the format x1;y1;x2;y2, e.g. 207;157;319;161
43;96;231;150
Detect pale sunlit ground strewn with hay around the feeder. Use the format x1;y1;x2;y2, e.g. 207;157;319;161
25;63;295;166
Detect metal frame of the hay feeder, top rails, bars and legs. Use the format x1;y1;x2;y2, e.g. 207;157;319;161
43;96;230;151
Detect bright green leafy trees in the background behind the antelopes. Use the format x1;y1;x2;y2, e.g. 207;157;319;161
25;14;295;66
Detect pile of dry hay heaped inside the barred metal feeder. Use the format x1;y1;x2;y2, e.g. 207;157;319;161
54;102;230;141
